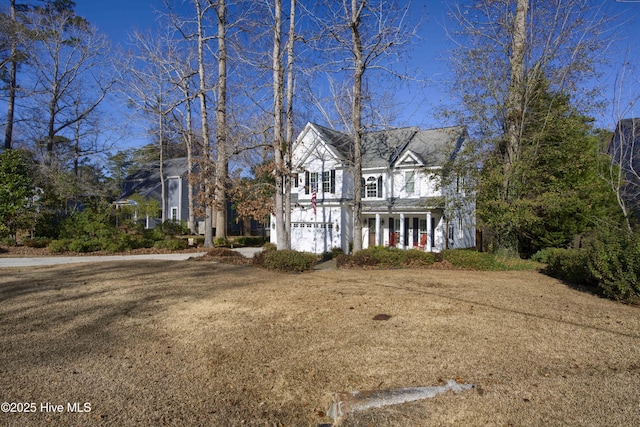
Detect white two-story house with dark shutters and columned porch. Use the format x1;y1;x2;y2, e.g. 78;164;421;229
271;123;475;253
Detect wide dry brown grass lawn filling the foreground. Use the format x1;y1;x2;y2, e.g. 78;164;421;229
0;261;640;426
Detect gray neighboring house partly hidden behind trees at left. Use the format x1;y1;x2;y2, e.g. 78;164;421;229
116;157;263;235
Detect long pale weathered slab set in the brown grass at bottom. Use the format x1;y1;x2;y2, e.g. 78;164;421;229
327;380;473;422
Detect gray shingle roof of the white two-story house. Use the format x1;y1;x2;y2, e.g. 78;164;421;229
311;123;466;168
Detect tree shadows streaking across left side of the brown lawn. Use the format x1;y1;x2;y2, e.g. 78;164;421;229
0;261;268;372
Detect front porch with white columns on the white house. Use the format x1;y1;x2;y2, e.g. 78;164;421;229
362;210;446;252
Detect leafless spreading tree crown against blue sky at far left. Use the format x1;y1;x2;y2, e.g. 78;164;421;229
29;6;115;164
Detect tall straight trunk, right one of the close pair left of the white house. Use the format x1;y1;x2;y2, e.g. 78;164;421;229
214;0;229;239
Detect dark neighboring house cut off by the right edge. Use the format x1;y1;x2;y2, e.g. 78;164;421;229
608;118;640;215
